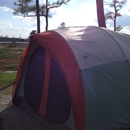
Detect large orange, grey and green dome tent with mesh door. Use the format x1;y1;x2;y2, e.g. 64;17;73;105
12;26;130;130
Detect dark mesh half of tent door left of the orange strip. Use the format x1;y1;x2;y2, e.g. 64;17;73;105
24;47;45;111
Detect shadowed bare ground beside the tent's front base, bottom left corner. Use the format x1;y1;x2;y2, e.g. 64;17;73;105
0;93;47;130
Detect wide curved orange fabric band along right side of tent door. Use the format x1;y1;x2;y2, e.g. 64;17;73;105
31;31;84;129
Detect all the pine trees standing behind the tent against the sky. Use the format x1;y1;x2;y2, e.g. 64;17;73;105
13;0;127;35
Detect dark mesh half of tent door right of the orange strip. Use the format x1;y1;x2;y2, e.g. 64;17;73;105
46;59;71;124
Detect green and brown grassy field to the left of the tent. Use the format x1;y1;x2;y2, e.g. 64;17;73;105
0;44;26;94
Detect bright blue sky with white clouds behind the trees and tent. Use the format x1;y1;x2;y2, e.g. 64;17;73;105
0;0;130;38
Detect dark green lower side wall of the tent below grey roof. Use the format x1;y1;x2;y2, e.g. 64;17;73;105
82;61;130;129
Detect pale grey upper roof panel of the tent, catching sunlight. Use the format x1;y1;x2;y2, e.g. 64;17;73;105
57;27;130;69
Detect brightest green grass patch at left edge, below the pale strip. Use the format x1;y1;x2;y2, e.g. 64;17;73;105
0;72;16;88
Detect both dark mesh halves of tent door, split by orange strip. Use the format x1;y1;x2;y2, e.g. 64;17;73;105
24;46;71;124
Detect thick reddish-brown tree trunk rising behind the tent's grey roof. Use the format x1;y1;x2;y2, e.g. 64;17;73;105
96;0;106;28
